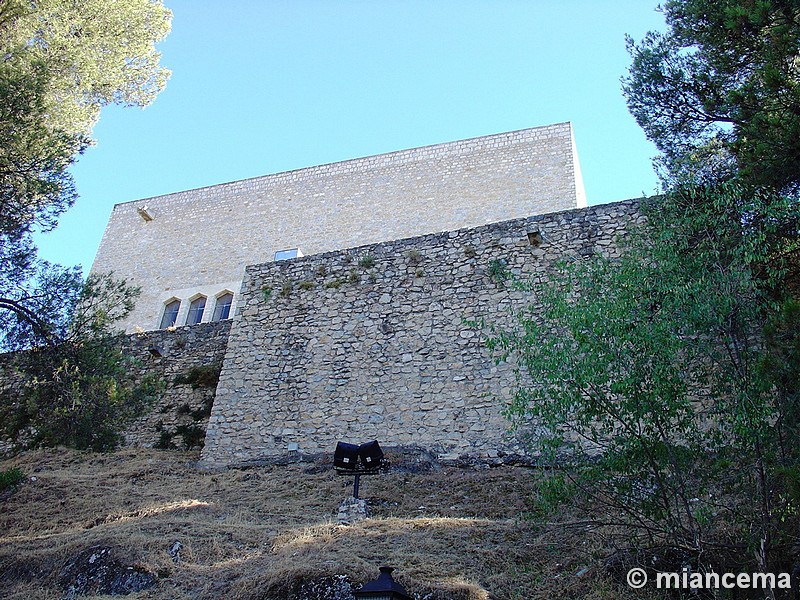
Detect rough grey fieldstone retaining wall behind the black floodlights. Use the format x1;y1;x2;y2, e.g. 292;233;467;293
203;202;641;465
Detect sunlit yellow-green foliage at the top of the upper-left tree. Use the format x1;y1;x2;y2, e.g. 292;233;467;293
10;0;171;138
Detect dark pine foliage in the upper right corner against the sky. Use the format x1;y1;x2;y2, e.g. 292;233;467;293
623;0;800;195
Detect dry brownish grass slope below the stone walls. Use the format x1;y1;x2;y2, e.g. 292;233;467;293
0;450;648;600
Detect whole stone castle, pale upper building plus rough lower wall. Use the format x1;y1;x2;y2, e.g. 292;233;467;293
87;123;639;465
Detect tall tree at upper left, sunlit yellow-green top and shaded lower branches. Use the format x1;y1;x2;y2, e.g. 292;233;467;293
0;0;171;348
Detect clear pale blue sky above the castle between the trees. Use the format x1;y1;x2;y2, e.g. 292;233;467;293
37;0;664;275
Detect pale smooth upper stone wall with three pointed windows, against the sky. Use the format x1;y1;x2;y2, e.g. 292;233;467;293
92;123;586;332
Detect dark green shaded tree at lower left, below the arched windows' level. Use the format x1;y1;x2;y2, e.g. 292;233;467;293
0;270;161;451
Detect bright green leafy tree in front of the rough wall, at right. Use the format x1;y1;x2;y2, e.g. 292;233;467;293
490;184;800;568
